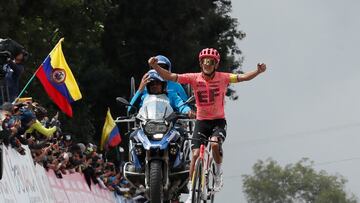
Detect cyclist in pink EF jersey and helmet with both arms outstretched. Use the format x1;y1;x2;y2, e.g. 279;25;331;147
148;48;266;200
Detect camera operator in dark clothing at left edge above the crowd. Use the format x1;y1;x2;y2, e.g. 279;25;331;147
0;39;28;103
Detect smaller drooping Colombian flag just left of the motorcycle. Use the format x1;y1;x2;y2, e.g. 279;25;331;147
100;108;121;150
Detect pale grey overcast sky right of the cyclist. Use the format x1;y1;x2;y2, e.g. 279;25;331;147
216;0;360;202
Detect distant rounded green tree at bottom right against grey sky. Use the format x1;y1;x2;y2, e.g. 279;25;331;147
243;159;357;203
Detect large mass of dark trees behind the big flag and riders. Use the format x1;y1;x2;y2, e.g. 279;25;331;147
0;0;245;147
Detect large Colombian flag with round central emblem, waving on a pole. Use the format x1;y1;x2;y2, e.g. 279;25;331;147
36;38;82;117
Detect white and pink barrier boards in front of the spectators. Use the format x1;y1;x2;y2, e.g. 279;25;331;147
0;145;129;203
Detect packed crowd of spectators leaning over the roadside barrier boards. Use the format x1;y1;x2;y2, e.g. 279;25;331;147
0;100;143;199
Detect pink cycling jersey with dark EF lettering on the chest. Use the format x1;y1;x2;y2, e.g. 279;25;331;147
178;72;232;120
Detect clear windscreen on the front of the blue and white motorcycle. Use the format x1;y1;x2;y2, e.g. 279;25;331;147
138;94;173;120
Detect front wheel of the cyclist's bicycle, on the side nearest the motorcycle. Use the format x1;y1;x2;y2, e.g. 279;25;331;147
191;159;203;203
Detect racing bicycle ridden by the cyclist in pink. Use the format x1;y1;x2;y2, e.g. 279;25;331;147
189;133;219;203
